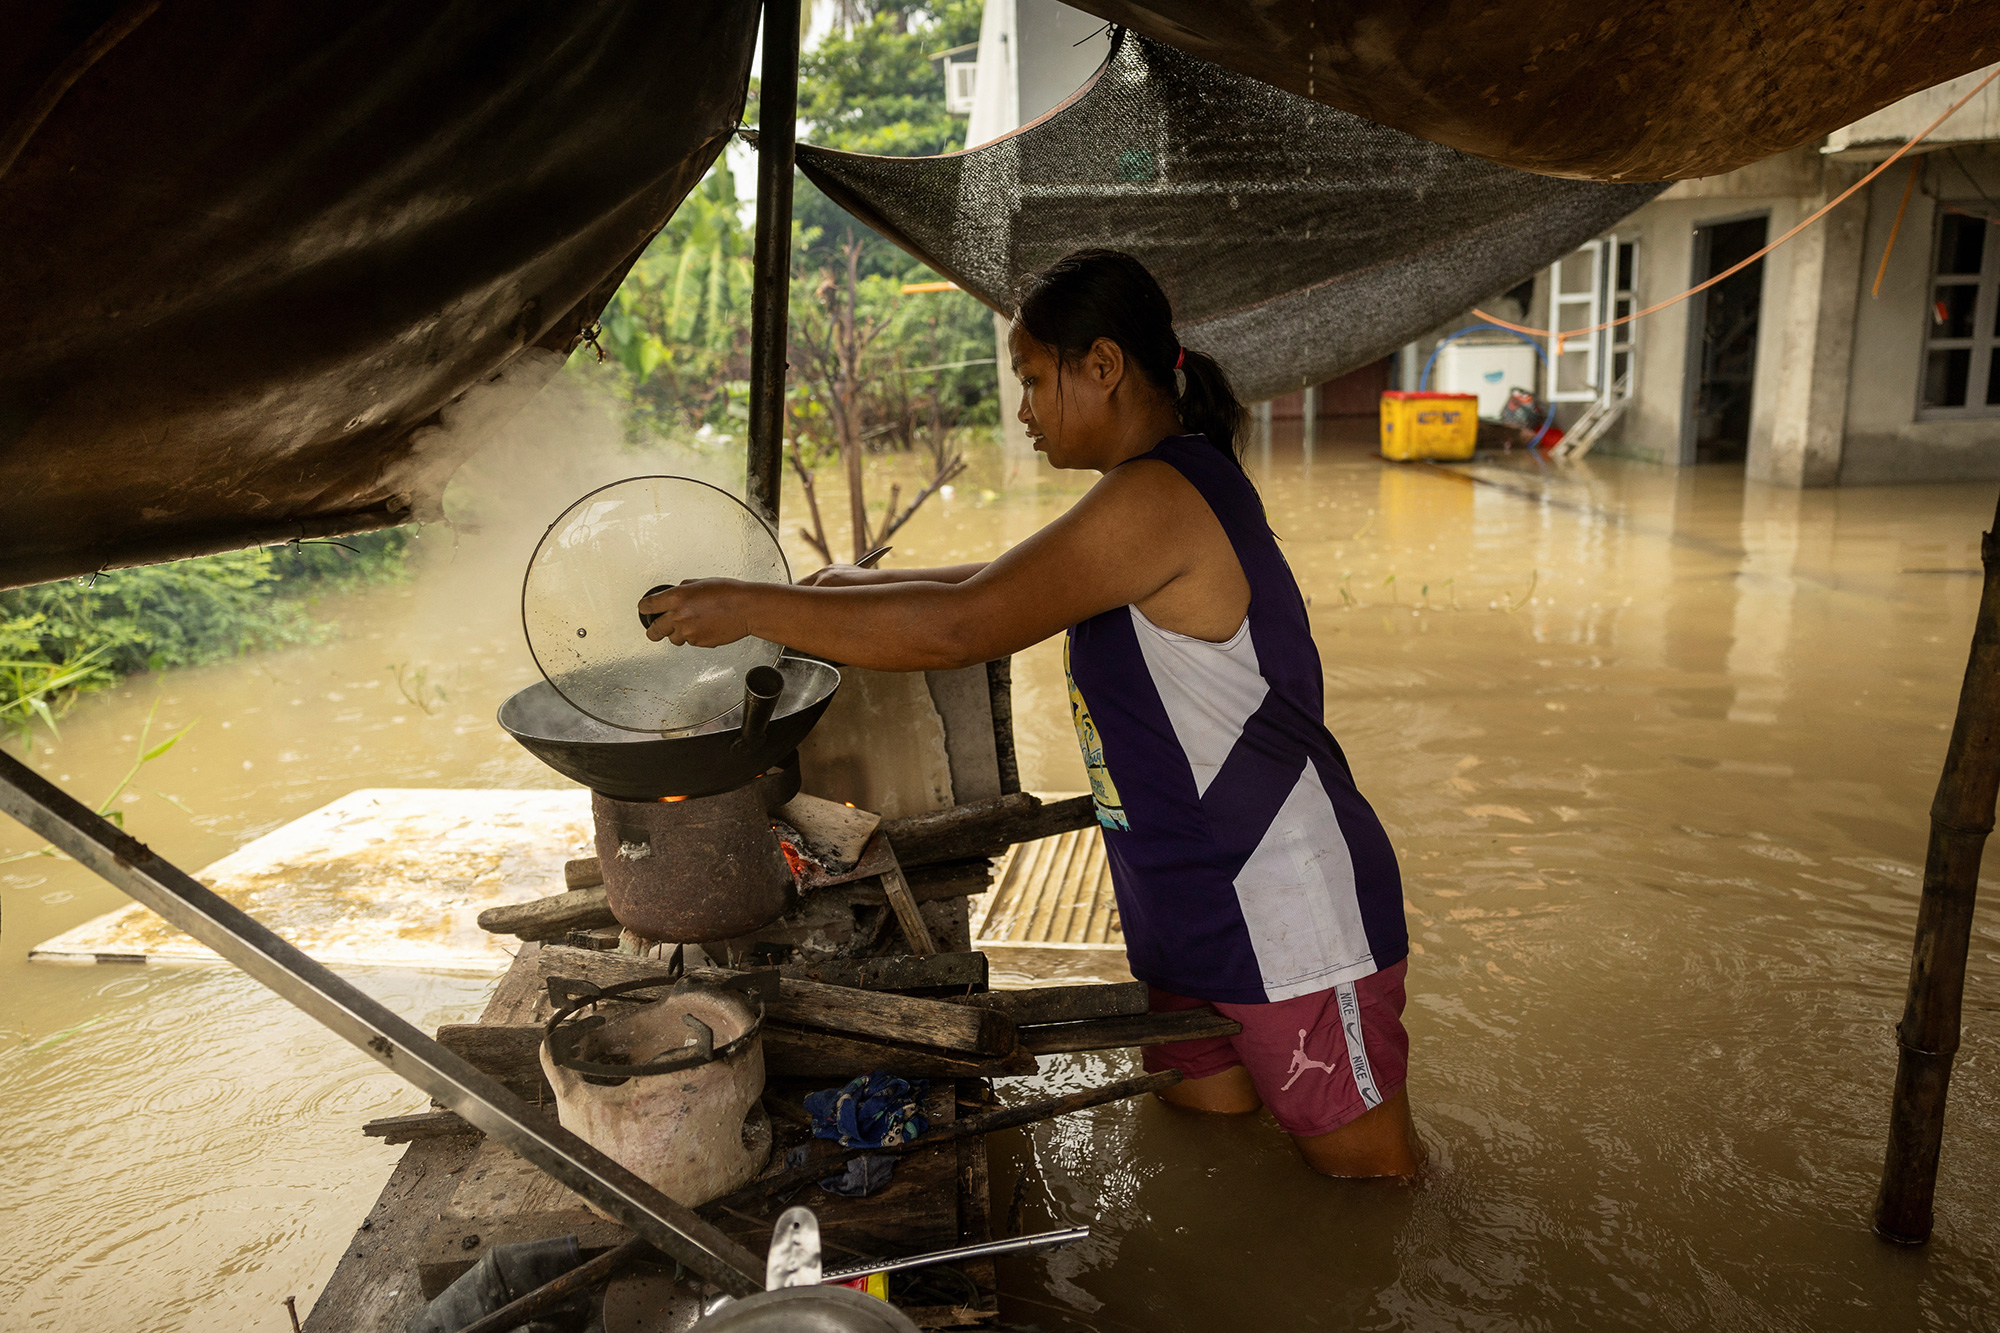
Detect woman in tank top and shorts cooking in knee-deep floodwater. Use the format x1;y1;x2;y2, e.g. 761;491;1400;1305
640;250;1422;1177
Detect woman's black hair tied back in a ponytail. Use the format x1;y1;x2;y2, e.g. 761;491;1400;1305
1014;250;1244;468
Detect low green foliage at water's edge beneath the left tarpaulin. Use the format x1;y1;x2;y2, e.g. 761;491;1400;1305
0;528;410;735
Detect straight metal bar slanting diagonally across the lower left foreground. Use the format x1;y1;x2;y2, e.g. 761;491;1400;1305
0;751;764;1295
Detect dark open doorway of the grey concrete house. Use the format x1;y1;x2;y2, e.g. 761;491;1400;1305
1680;216;1768;464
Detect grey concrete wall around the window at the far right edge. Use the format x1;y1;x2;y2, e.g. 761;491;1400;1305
1838;148;2000;486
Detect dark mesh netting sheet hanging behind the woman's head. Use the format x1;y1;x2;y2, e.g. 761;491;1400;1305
798;34;1664;398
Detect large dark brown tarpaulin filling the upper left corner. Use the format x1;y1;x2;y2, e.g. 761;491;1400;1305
0;0;758;586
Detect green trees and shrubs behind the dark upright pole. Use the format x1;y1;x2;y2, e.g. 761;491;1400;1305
582;0;996;440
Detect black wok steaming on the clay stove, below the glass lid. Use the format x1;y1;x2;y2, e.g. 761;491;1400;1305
500;656;840;801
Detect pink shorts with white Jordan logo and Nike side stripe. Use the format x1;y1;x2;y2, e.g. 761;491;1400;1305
1146;959;1410;1139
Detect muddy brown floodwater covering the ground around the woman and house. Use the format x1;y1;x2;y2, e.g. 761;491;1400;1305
0;400;2000;1333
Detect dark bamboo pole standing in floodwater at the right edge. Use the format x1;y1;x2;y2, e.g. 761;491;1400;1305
1874;490;2000;1245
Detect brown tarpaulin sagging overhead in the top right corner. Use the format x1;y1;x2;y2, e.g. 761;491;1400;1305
1066;0;2000;180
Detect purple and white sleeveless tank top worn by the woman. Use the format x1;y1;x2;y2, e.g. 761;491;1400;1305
1064;434;1410;1005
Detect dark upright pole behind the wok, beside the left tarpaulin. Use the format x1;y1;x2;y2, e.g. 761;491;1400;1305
744;0;798;526
